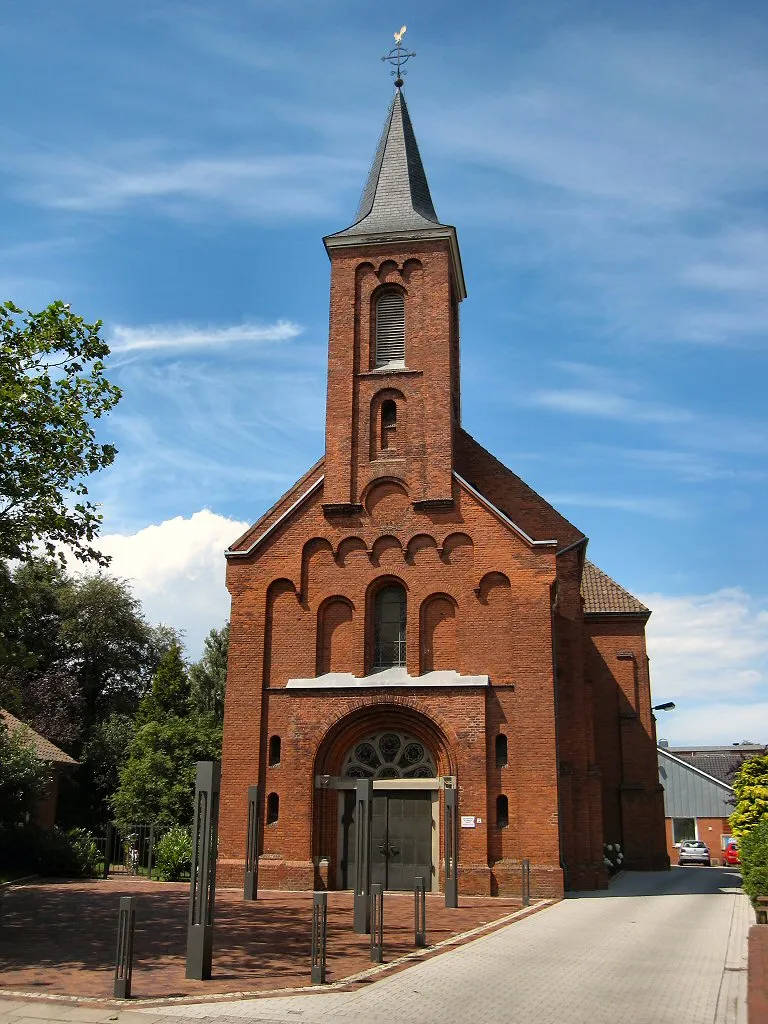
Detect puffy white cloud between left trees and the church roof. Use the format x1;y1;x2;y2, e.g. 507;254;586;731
72;509;250;658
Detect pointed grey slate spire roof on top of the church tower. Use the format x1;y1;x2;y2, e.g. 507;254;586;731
329;89;447;239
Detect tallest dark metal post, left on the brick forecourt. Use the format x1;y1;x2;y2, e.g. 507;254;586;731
186;761;221;981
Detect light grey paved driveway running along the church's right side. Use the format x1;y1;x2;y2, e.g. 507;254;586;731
0;867;754;1024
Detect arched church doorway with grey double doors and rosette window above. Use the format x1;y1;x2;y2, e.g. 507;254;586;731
337;729;438;890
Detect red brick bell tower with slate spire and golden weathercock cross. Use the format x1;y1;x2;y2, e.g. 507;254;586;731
324;68;466;516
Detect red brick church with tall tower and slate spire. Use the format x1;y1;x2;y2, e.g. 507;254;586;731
218;82;669;896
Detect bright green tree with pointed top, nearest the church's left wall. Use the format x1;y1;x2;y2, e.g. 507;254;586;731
113;645;221;829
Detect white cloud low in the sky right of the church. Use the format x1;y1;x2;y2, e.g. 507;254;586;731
641;588;768;745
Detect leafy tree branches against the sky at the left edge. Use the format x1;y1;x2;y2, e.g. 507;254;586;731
0;302;121;564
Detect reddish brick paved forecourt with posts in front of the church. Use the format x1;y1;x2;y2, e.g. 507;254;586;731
0;878;519;1009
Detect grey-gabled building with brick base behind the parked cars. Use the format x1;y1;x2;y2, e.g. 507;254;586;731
658;740;741;864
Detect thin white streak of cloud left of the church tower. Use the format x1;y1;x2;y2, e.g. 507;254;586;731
110;321;302;353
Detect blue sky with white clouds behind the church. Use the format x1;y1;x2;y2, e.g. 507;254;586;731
0;0;768;743
